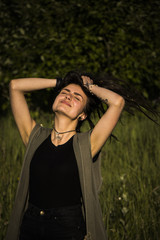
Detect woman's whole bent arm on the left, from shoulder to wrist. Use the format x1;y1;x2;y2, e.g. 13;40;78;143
9;78;56;145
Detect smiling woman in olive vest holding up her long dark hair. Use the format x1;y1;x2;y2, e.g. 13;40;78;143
6;72;158;240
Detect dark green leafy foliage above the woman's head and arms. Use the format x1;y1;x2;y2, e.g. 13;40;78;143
0;0;160;113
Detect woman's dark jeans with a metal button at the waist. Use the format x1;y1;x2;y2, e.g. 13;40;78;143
19;204;86;240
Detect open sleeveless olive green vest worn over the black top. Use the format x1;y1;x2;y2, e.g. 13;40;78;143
5;124;107;240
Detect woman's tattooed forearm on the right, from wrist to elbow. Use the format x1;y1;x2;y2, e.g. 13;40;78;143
88;84;125;107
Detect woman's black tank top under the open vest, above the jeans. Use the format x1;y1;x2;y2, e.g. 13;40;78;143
29;135;82;209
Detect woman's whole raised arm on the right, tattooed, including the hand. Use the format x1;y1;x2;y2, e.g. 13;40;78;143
82;76;125;157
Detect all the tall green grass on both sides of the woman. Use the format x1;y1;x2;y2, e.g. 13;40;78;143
0;113;160;240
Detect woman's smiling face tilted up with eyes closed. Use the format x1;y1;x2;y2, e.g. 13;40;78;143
52;84;87;120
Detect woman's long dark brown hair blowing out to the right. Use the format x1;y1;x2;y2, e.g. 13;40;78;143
54;71;159;131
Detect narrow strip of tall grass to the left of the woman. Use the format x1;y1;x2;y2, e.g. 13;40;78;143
0;117;25;239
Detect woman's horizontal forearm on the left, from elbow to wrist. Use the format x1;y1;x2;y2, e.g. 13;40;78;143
10;78;57;92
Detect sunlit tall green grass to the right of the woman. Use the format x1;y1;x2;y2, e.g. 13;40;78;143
101;113;160;240
